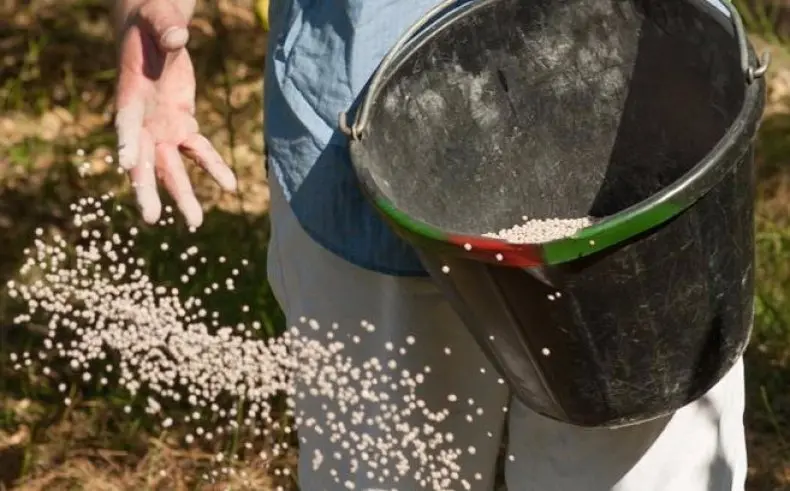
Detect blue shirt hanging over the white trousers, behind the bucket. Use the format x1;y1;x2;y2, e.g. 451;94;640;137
265;0;736;276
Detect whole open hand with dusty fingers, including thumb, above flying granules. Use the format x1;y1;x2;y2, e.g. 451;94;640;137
114;0;237;227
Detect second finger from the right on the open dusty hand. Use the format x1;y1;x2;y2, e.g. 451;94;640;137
156;144;203;227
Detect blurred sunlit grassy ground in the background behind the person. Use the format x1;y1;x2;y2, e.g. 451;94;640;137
0;0;790;491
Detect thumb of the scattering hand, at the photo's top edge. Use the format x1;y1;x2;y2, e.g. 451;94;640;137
137;0;189;51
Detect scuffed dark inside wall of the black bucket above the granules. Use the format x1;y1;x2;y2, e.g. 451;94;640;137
352;0;745;235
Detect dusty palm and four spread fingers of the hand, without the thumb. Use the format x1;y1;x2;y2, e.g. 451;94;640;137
116;17;236;226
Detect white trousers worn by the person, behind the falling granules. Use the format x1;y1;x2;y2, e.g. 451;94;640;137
269;179;746;491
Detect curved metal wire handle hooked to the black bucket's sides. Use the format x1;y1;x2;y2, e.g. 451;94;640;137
338;0;771;141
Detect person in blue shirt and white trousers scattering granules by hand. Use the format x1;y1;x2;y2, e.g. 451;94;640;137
111;0;747;491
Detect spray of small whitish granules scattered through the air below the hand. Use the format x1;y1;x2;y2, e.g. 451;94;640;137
7;190;498;490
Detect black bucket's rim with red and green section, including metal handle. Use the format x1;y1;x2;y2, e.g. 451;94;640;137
340;0;770;267
